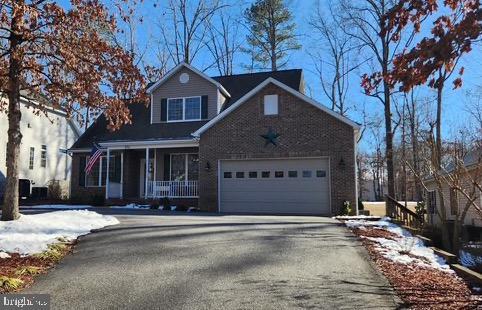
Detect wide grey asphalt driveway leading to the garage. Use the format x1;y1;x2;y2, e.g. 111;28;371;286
25;210;396;310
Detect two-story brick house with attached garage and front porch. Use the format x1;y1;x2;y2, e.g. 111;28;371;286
71;63;359;215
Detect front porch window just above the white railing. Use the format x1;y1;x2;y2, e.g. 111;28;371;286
170;154;199;181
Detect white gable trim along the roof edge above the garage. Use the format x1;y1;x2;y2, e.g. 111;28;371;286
192;77;360;137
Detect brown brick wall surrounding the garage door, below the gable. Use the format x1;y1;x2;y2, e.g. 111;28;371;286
199;84;356;214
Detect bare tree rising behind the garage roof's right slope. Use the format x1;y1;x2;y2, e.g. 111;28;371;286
309;2;359;115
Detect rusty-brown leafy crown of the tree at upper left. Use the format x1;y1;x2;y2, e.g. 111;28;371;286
0;0;145;130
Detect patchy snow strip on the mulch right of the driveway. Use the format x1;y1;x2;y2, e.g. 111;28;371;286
345;217;453;272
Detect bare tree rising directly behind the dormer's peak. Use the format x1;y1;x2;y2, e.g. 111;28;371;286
160;0;225;64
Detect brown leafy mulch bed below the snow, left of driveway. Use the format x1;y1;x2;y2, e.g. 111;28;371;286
0;242;75;294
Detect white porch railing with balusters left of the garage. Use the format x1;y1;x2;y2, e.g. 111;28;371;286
147;181;198;198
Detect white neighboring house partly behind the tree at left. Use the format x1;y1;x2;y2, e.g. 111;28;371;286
0;98;80;197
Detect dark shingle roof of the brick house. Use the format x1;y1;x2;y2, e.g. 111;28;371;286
72;69;302;149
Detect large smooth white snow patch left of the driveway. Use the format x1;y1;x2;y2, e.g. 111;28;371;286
0;210;119;256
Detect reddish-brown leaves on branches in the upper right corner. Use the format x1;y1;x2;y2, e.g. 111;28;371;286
362;0;482;93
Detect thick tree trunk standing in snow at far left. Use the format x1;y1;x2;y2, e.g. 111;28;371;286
1;14;22;221
